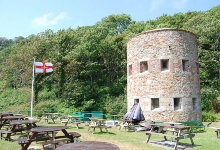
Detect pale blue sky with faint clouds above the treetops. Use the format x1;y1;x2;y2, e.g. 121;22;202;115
0;0;220;39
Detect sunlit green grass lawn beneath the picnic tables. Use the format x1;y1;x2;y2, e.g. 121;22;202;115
0;120;220;150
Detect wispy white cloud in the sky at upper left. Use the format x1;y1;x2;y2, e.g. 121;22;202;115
32;12;67;27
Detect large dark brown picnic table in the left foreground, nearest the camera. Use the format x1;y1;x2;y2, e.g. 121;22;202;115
19;126;74;150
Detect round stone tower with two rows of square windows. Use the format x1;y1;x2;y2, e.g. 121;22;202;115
127;28;202;122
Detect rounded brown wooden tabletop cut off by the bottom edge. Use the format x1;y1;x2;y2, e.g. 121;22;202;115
56;141;120;150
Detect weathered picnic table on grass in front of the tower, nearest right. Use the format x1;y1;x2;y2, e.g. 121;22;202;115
146;124;195;150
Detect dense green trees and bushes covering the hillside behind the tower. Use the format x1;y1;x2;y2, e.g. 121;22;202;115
0;6;220;114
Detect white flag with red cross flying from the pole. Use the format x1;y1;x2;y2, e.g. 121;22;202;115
34;62;53;73
